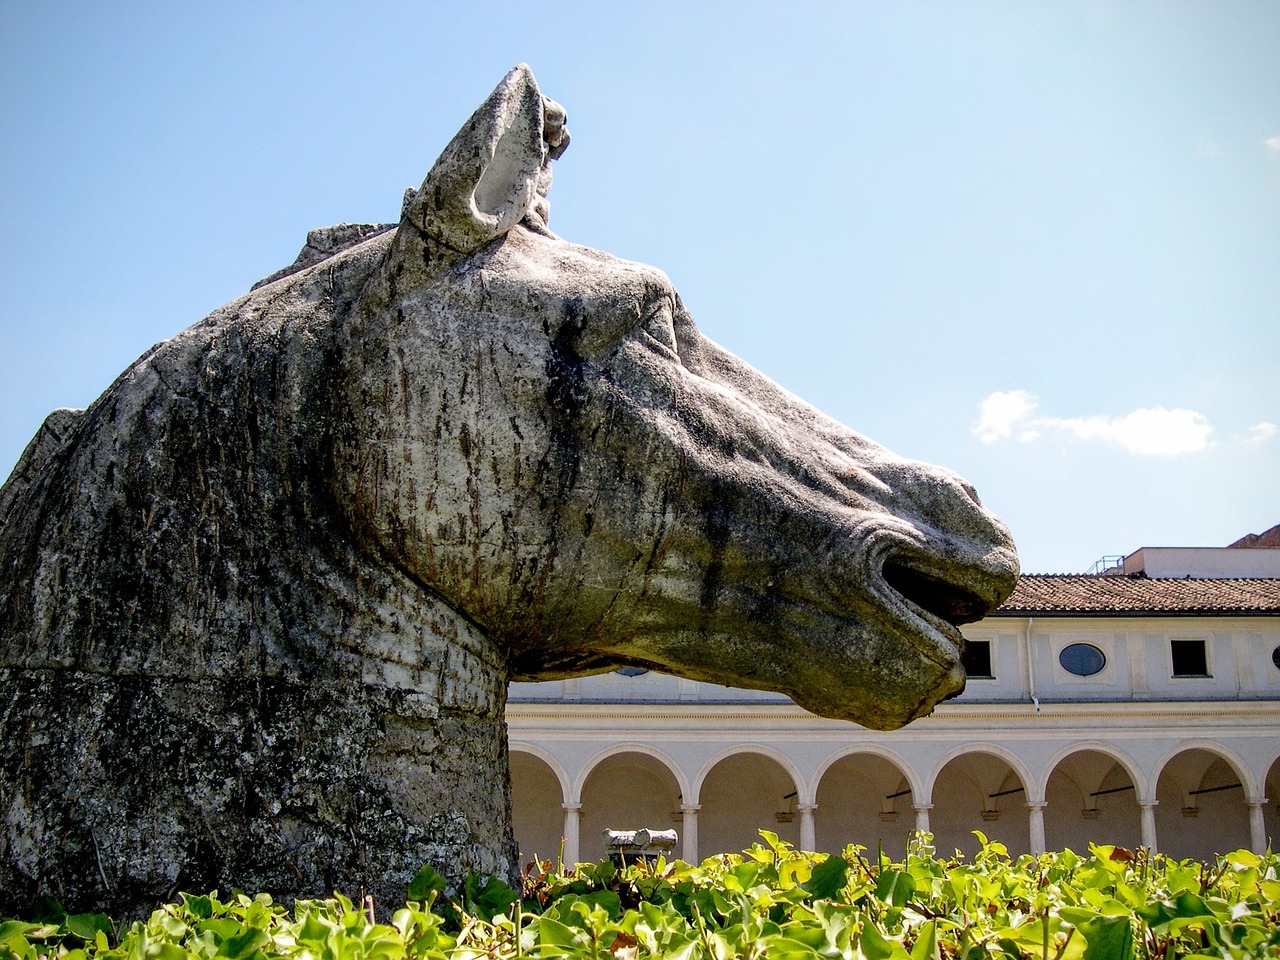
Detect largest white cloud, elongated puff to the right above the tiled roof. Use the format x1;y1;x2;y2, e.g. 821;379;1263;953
973;390;1213;457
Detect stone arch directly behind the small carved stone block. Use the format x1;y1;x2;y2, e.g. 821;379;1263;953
575;744;684;860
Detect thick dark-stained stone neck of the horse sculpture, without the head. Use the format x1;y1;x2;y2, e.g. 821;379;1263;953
0;227;515;913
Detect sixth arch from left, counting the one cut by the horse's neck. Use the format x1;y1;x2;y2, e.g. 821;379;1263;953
1042;742;1147;854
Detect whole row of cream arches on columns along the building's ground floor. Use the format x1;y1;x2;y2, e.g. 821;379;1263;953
511;741;1280;863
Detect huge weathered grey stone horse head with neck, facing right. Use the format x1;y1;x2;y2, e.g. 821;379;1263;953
0;67;1018;915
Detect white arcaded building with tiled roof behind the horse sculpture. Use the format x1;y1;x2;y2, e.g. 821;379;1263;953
507;548;1280;863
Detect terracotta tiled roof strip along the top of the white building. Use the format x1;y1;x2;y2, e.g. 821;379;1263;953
992;573;1280;617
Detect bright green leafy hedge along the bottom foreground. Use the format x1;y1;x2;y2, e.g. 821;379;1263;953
0;831;1280;960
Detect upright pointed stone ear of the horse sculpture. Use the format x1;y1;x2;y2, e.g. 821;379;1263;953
401;64;568;260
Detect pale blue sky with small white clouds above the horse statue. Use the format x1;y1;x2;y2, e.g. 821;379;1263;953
0;0;1280;572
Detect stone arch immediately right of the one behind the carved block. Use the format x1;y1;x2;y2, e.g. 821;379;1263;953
696;745;805;856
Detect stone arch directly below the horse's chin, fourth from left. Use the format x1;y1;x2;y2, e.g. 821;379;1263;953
814;746;922;858
